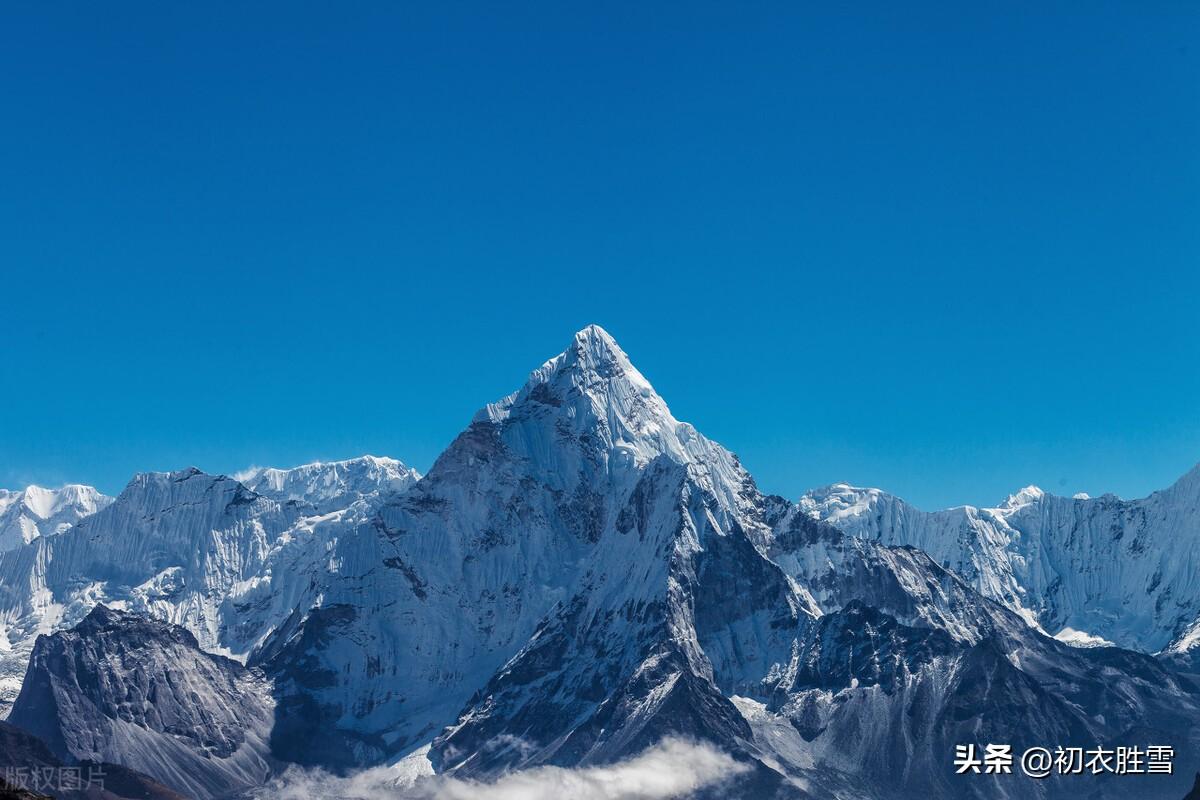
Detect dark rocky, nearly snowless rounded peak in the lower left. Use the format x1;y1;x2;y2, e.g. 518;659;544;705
8;606;272;799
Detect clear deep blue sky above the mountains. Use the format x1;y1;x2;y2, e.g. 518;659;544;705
0;1;1200;507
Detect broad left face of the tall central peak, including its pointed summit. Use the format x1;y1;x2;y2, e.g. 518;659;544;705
256;326;782;764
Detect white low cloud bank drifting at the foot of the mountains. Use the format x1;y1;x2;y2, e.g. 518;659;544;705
256;739;749;800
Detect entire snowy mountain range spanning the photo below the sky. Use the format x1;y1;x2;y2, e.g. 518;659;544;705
0;326;1200;799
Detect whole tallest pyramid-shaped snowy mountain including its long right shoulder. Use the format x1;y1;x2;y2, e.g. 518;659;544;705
243;329;1200;798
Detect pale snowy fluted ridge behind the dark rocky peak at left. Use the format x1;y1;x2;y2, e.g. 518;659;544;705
0;469;285;714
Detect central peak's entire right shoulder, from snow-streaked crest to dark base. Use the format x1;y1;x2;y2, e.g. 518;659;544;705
737;506;1200;798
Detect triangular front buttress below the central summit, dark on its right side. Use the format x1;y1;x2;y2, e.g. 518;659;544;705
431;456;811;796
